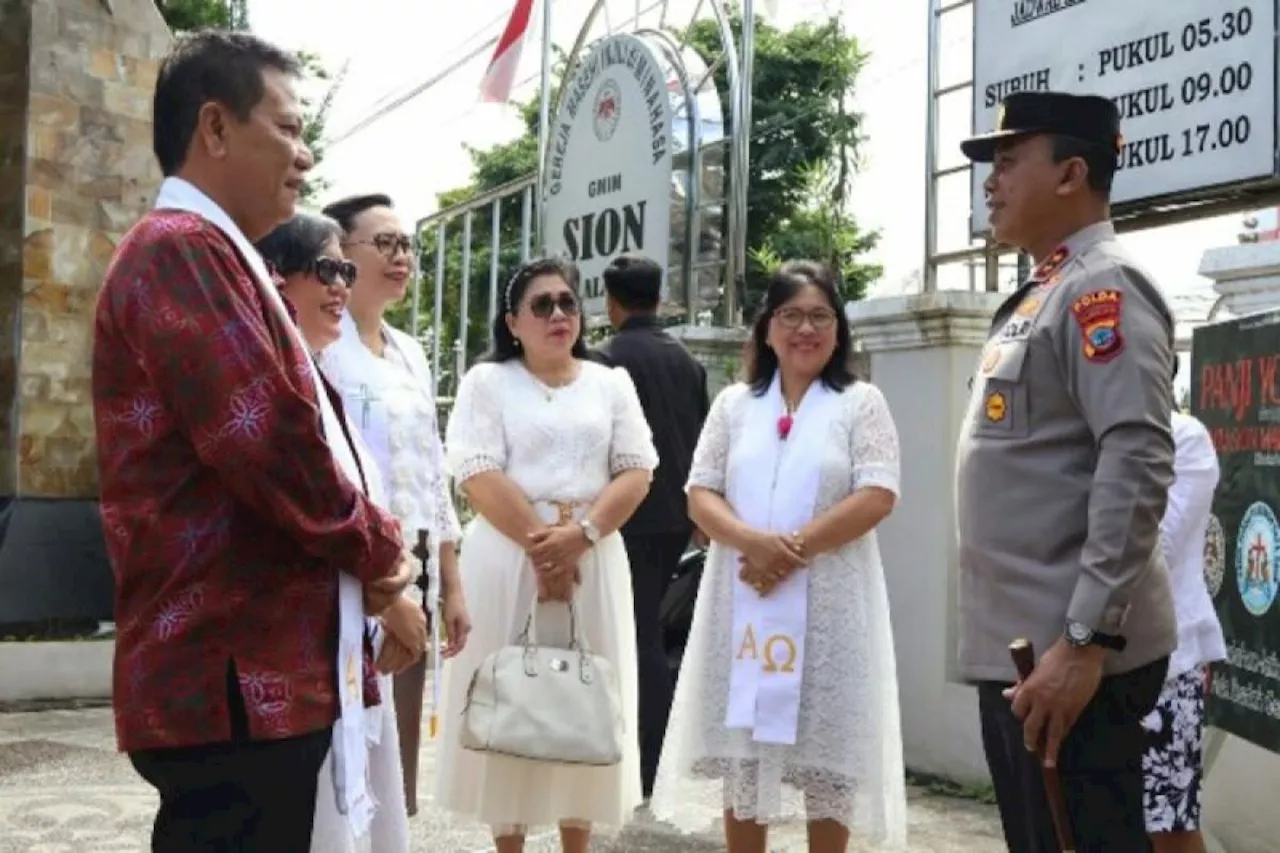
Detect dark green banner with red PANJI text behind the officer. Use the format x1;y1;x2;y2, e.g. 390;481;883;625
1192;311;1280;752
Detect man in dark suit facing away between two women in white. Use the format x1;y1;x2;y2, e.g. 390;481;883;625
593;255;708;798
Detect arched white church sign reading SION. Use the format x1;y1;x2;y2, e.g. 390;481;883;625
543;36;672;316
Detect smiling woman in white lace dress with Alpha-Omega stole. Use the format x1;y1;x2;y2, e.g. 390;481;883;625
652;263;906;853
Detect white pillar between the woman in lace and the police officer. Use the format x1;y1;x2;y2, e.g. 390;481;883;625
846;291;1004;781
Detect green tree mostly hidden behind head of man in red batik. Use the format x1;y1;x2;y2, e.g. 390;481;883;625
155;0;347;205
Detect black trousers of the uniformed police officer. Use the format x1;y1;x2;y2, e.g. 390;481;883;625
978;658;1169;853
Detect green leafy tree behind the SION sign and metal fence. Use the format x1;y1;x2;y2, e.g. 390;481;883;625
399;13;881;381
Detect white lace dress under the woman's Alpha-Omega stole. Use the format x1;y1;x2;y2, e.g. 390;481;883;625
652;382;906;849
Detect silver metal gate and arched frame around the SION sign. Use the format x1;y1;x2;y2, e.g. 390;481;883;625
410;0;755;394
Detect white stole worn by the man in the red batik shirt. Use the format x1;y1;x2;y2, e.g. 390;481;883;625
155;178;376;838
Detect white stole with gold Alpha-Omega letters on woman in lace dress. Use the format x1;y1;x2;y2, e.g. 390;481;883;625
724;375;840;744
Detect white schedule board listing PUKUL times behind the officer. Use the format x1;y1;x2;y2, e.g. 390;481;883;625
972;0;1276;234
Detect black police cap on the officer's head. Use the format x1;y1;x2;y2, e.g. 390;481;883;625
960;92;1121;163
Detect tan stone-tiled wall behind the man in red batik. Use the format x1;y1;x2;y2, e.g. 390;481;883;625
0;0;170;498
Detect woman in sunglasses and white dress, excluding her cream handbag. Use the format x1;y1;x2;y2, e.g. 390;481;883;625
435;260;658;853
